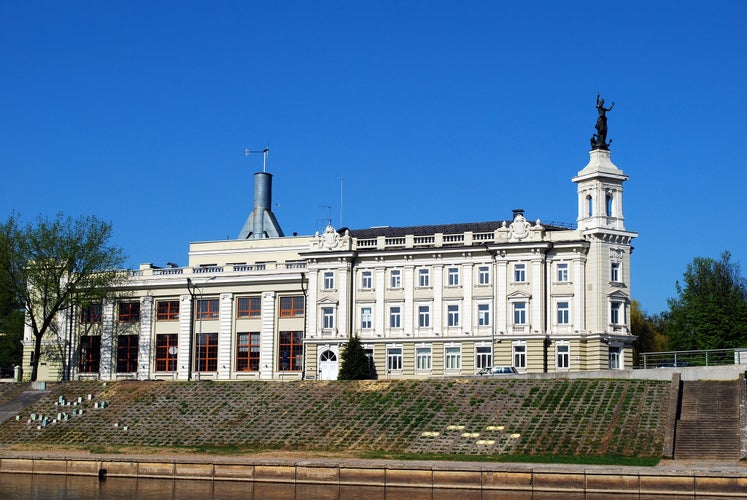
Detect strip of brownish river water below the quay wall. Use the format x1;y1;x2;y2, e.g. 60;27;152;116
0;473;536;500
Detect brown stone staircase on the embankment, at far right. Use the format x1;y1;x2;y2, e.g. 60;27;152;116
674;381;743;461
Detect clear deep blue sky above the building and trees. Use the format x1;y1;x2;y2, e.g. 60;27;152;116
0;0;747;313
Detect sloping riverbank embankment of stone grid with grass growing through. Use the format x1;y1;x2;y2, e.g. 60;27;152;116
0;379;670;458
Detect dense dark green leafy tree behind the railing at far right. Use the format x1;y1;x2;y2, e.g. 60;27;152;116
665;251;747;350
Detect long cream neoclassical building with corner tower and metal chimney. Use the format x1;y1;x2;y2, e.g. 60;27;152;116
25;148;637;380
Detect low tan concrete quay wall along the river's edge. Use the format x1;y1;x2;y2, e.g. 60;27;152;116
0;456;747;498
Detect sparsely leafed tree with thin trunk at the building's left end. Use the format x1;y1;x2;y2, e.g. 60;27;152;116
0;214;124;381
